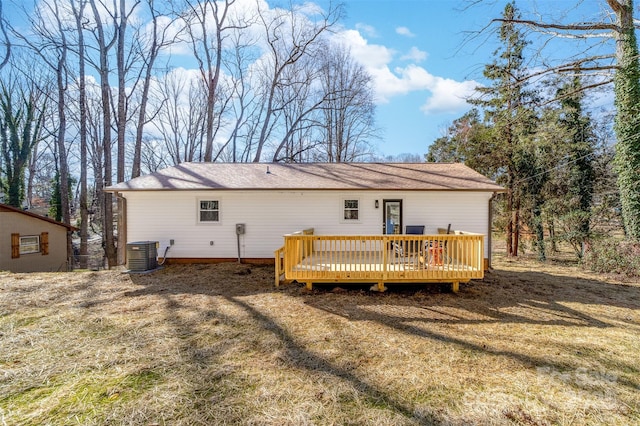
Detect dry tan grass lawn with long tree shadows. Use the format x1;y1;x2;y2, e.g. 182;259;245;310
0;258;640;425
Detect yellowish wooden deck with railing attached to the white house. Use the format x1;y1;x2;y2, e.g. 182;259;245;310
275;232;484;291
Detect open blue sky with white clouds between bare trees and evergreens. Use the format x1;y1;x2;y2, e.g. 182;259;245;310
330;0;607;155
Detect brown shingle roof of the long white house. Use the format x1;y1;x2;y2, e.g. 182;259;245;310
106;163;503;192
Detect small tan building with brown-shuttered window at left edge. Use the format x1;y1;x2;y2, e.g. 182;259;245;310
0;204;75;272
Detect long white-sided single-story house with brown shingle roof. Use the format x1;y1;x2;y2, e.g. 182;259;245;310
108;163;502;261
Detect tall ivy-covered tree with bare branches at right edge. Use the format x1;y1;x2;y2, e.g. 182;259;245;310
488;0;640;241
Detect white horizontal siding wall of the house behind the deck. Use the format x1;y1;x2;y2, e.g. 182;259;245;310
124;190;491;258
